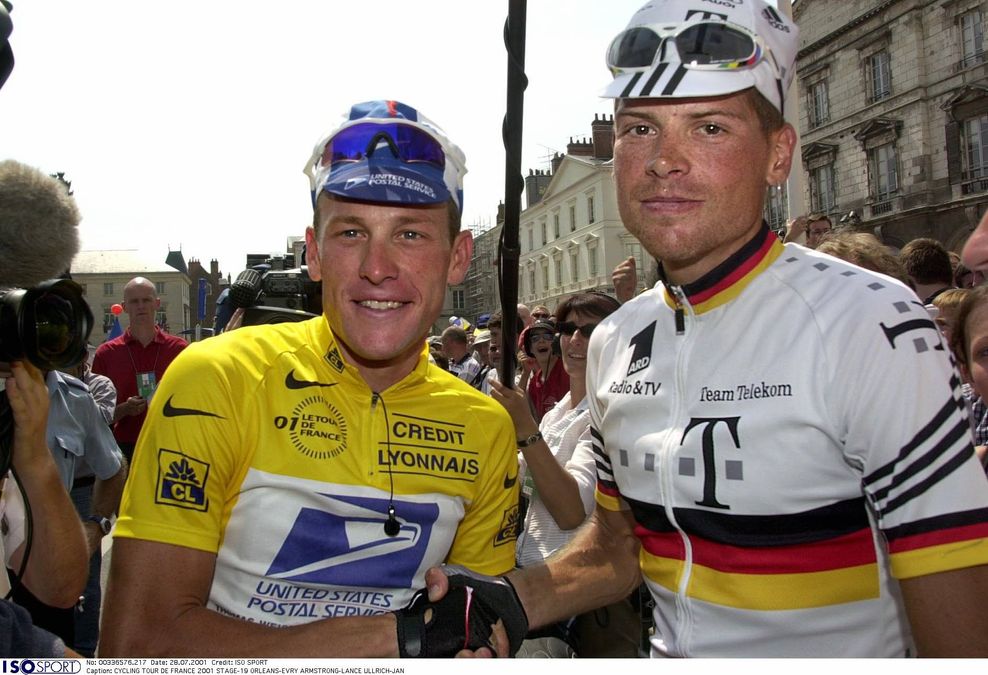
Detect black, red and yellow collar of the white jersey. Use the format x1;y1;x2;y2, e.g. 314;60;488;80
659;221;783;314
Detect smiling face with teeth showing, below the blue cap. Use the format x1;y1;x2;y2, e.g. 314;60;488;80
305;194;473;391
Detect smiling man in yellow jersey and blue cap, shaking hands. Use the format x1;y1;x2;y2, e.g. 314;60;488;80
100;101;518;657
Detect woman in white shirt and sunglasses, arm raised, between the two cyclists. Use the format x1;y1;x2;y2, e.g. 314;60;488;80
491;293;620;655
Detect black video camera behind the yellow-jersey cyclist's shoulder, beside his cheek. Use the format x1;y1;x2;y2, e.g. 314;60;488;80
229;258;322;326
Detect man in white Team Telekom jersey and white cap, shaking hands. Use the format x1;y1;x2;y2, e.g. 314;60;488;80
428;0;988;657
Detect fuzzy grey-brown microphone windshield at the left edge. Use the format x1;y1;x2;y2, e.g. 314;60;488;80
0;159;81;288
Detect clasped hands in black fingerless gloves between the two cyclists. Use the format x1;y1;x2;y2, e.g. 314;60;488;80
395;565;528;658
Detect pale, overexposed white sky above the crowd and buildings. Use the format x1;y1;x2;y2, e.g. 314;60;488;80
0;0;643;277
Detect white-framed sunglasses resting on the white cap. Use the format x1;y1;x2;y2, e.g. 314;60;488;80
607;21;775;75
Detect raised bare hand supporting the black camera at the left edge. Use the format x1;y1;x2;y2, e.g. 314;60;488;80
6;361;51;472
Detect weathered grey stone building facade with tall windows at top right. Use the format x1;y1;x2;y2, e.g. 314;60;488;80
793;0;988;251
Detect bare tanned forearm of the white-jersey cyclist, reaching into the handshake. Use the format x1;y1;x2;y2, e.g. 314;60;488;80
508;508;641;628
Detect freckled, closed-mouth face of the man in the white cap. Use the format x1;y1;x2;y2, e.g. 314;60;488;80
614;90;796;284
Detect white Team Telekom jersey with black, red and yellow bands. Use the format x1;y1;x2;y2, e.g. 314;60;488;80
587;227;988;657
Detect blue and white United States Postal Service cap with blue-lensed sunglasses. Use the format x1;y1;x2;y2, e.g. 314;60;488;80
305;101;467;213
